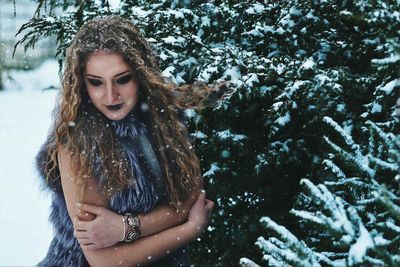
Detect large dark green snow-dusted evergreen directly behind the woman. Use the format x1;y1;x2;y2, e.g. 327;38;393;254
20;0;400;266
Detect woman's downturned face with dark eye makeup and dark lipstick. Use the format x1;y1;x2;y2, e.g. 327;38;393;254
83;51;139;120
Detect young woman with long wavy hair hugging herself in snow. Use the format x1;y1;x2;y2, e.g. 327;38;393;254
36;17;214;267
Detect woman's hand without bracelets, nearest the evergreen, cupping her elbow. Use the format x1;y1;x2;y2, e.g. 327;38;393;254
186;191;214;238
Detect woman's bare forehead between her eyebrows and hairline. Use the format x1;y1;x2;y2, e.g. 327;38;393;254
85;51;130;77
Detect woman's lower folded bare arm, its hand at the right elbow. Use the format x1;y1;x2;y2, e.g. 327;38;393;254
59;150;214;266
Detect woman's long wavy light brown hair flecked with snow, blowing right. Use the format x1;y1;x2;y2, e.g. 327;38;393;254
44;16;209;207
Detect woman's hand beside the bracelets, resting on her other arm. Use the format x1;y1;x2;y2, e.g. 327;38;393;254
74;204;124;249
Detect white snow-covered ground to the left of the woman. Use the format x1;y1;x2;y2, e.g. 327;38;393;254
0;61;59;267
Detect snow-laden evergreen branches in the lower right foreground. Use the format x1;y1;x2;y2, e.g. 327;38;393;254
243;117;400;266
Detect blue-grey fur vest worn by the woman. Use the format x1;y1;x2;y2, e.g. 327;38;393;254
36;111;190;267
